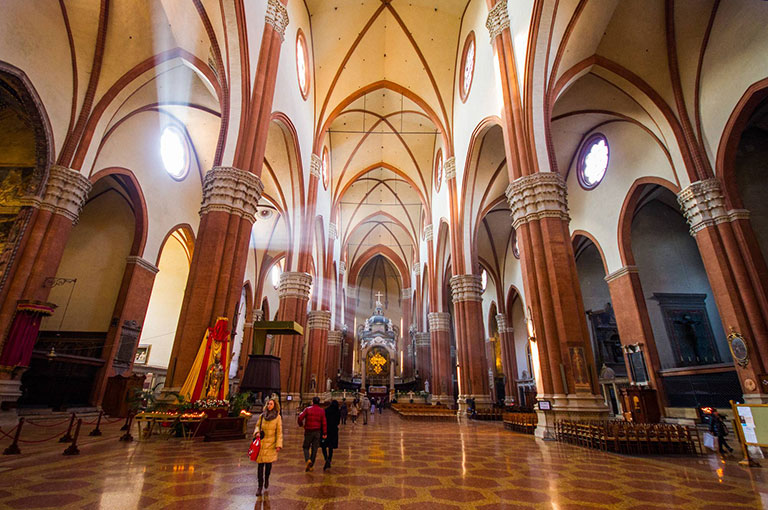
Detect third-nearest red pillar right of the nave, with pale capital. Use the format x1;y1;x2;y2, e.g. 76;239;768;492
426;312;453;403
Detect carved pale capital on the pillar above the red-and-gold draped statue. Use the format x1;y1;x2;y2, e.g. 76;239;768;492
200;166;264;223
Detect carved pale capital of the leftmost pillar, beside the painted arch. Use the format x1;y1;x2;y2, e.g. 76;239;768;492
37;165;92;223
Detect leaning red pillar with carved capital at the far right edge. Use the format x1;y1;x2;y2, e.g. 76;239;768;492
677;179;768;403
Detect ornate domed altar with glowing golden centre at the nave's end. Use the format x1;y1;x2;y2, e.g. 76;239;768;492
360;293;397;397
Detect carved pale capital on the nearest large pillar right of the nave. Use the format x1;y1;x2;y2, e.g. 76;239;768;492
506;172;570;230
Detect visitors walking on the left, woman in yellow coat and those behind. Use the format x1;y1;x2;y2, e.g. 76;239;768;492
253;396;381;496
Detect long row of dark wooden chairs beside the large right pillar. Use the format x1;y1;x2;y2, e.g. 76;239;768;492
555;420;702;455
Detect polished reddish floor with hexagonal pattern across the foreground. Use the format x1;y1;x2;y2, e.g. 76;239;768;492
0;412;768;510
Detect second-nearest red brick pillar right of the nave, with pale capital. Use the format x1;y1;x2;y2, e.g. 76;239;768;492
451;274;493;406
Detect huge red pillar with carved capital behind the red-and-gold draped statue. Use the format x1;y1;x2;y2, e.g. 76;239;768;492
167;167;263;389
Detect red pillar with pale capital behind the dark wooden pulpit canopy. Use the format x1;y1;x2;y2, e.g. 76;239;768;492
272;271;312;402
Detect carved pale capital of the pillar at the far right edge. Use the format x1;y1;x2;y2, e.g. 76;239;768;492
677;178;749;237
